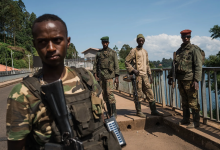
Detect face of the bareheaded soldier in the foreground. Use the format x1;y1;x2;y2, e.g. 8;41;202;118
33;20;70;66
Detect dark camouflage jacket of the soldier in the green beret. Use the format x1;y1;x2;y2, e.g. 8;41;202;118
93;48;119;79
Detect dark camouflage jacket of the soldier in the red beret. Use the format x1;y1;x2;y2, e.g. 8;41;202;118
169;43;202;82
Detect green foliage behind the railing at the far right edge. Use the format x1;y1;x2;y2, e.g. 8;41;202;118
204;51;220;94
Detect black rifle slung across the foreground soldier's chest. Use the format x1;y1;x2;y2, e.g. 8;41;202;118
41;79;83;150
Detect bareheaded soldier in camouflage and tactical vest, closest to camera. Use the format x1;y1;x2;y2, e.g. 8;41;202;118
6;14;121;150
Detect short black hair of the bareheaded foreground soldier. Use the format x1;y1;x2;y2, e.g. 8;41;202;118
31;14;68;36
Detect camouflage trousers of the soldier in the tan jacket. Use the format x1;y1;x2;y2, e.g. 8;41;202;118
136;75;155;102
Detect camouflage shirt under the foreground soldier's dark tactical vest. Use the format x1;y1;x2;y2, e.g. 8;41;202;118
6;67;101;145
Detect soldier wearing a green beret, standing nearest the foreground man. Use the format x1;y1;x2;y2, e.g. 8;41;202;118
93;36;119;117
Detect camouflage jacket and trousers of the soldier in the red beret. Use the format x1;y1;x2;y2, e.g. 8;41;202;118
168;43;202;111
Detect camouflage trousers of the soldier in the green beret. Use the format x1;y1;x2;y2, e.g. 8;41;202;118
100;79;116;104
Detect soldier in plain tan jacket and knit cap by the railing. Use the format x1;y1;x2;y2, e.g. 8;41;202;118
125;34;162;118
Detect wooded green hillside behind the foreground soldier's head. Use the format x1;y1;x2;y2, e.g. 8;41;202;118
0;0;78;68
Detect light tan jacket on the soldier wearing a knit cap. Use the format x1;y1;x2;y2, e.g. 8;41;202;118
125;48;151;75
